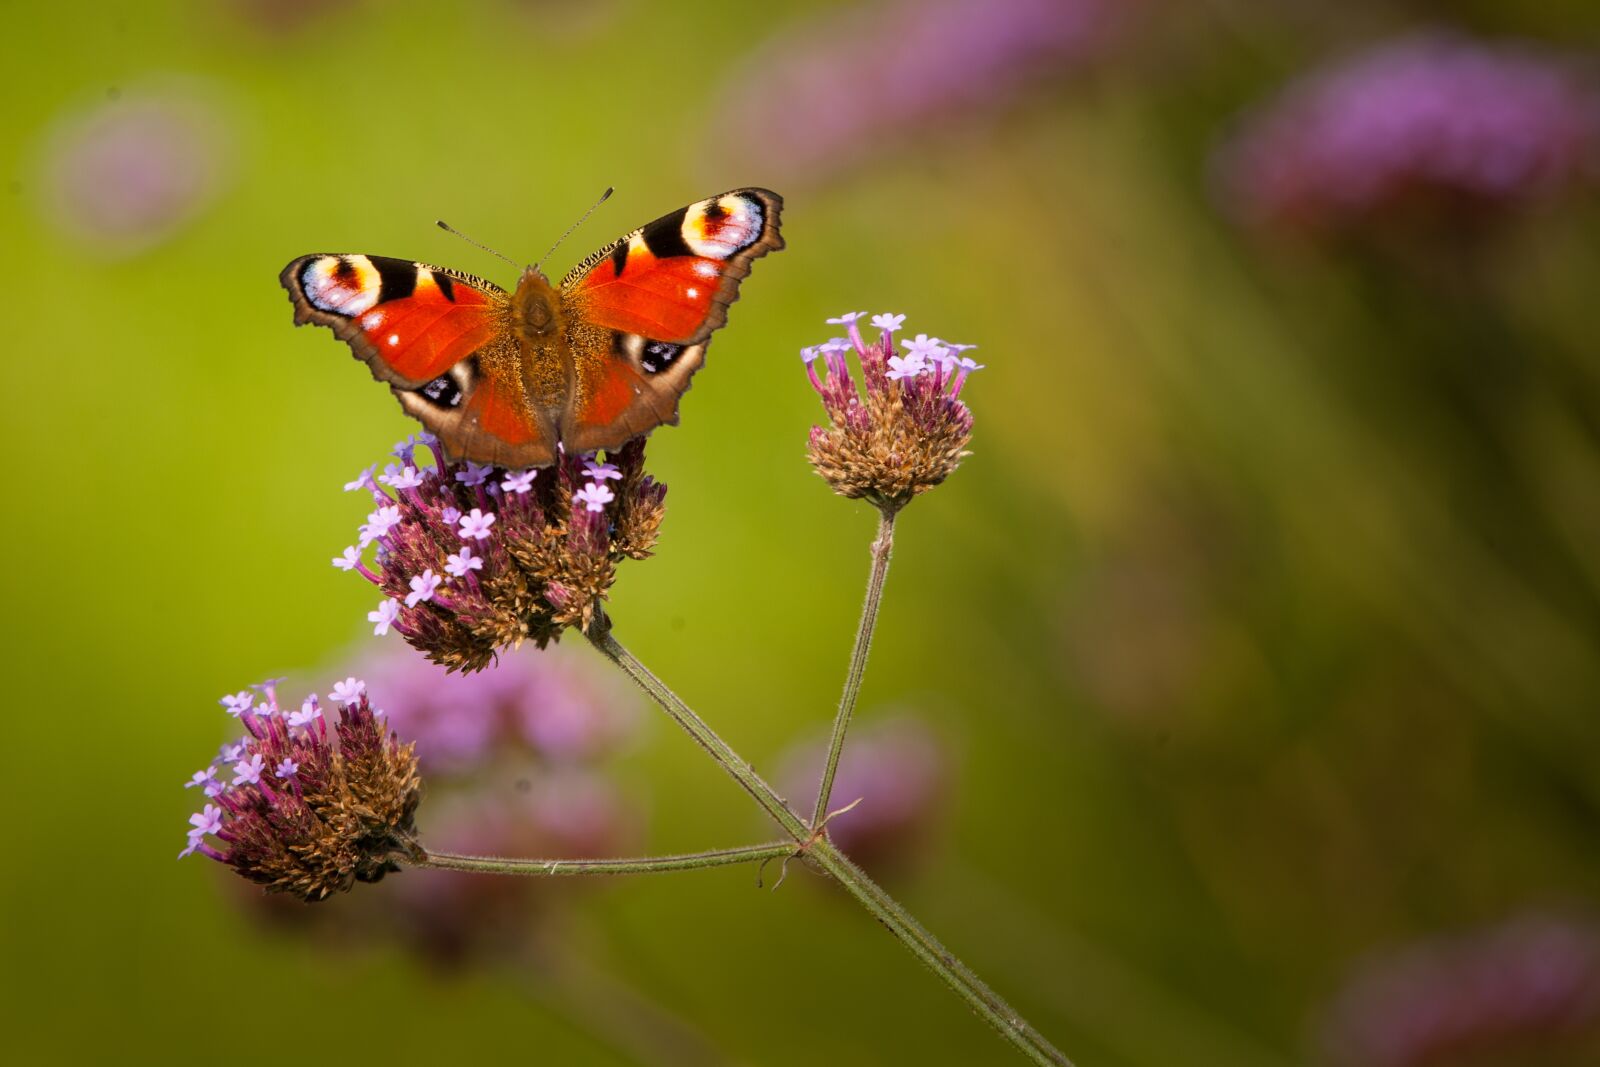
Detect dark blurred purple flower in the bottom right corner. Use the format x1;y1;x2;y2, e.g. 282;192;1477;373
1323;917;1600;1067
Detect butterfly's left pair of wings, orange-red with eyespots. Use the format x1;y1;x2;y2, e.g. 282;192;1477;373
280;254;557;467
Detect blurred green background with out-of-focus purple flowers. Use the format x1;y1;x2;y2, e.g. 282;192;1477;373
9;0;1600;1067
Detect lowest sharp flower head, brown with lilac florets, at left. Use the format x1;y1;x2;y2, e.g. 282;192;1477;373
179;678;422;901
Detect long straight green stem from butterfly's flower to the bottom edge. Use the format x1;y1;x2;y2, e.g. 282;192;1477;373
586;620;1072;1067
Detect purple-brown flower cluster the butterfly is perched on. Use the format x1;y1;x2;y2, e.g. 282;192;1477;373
333;434;667;670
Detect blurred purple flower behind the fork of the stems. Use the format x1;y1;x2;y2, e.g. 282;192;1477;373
778;717;949;870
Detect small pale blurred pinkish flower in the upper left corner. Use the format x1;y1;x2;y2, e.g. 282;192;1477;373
43;90;229;256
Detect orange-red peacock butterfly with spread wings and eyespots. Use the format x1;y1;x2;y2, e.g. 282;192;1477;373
289;189;784;469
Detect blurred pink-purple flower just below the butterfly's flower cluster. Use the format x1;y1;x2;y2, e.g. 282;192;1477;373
360;633;634;777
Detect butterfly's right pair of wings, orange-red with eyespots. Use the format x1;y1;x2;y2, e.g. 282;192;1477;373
560;189;784;451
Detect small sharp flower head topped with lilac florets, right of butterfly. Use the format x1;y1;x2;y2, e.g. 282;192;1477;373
800;312;982;514
